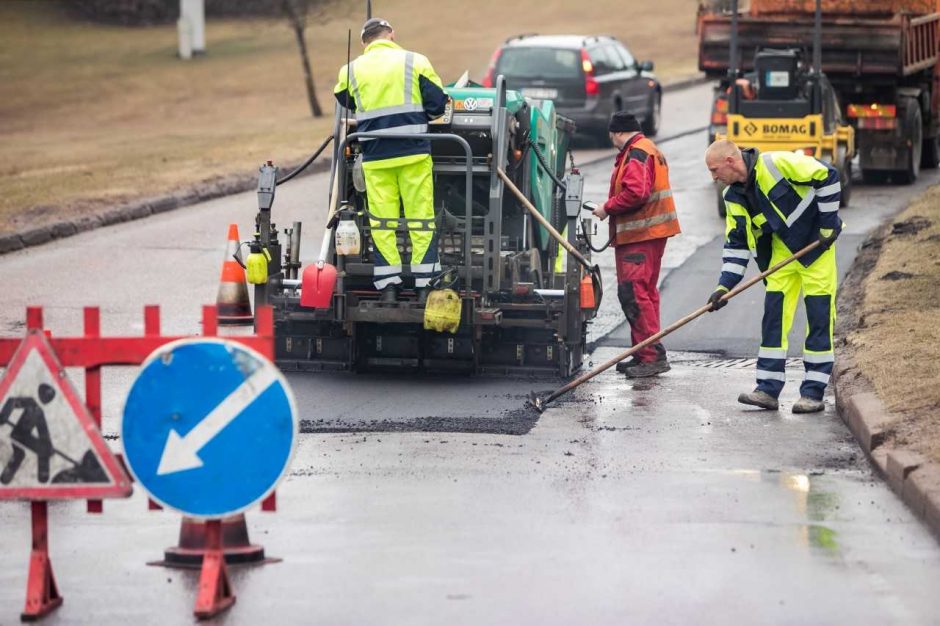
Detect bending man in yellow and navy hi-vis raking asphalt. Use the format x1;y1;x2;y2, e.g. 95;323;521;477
705;140;842;413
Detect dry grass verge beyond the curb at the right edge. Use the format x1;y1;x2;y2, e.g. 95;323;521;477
849;186;940;463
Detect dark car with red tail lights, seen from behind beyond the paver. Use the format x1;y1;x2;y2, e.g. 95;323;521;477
483;35;662;144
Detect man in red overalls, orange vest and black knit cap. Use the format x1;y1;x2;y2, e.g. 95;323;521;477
594;111;680;378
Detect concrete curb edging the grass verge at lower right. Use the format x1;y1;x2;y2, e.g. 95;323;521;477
832;258;940;541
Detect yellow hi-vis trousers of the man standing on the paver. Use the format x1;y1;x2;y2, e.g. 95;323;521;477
363;154;441;289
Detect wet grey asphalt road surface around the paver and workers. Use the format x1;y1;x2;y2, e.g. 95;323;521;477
0;80;940;625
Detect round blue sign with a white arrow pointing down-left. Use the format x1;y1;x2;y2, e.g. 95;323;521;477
121;339;298;518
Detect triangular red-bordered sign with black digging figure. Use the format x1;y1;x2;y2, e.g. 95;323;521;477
0;331;131;500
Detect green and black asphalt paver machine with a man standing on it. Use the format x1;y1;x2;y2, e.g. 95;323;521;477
244;77;601;376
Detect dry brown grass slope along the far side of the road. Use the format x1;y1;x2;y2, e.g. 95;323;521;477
0;0;696;233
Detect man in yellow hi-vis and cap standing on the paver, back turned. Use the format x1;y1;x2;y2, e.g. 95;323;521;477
333;18;447;304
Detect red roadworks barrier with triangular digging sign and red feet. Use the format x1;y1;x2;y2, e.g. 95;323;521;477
0;306;275;621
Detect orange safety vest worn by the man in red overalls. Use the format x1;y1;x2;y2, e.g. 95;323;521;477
611;137;681;245
